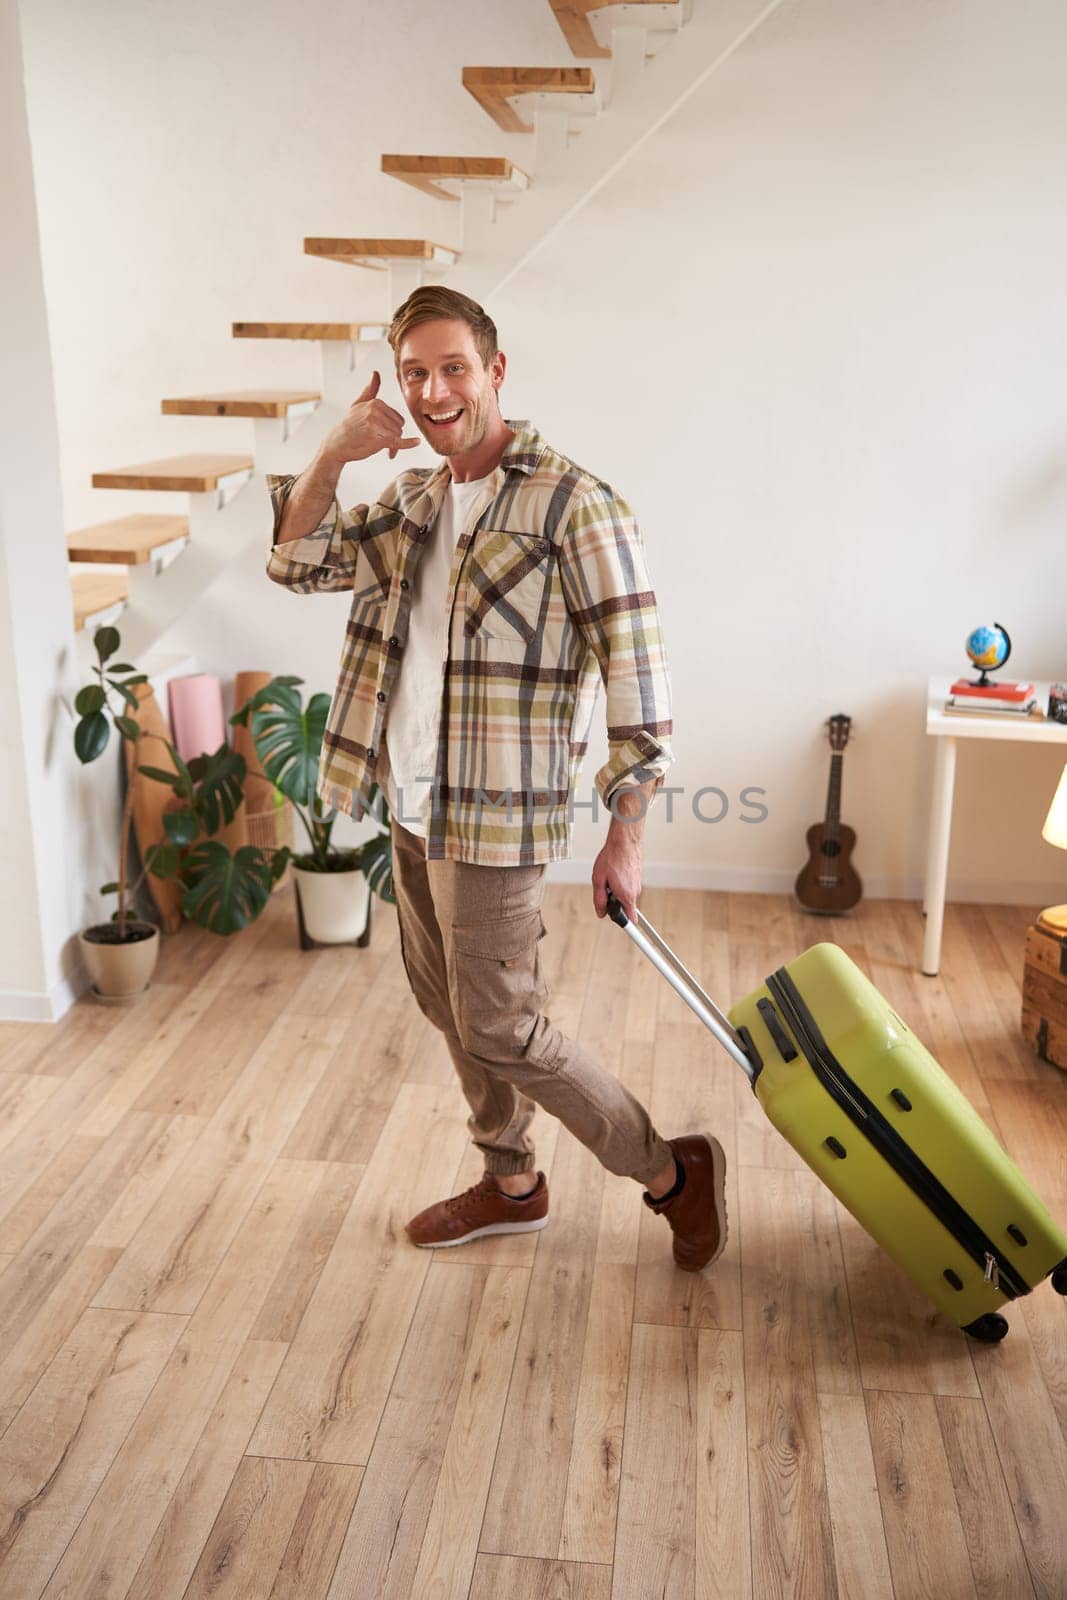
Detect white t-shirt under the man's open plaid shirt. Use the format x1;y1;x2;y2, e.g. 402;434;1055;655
378;478;485;838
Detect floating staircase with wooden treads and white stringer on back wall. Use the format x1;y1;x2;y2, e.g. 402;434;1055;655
75;0;716;659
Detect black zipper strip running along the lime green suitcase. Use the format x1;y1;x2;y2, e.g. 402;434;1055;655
766;966;1030;1299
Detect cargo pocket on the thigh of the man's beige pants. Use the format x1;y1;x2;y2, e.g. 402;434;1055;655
451;910;547;1061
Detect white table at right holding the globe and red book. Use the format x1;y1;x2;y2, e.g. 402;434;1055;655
923;678;1067;978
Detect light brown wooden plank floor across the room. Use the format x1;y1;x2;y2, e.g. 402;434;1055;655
0;886;1067;1600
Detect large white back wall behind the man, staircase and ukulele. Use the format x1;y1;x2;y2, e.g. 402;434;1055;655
18;0;1067;901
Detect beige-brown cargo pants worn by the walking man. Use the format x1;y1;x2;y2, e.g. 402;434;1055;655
392;818;672;1184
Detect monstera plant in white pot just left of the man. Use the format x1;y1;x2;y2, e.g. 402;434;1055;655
230;677;395;949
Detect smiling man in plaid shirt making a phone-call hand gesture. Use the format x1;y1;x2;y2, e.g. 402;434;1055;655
267;288;726;1270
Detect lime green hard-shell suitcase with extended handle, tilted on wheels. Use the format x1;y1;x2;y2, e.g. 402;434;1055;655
609;898;1067;1342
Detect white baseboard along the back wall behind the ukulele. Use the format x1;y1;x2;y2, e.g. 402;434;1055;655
547;861;1064;906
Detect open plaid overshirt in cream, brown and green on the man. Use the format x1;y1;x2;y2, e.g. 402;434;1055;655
267;422;673;866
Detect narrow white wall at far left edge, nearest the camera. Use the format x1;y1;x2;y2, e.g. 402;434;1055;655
0;0;97;1021
